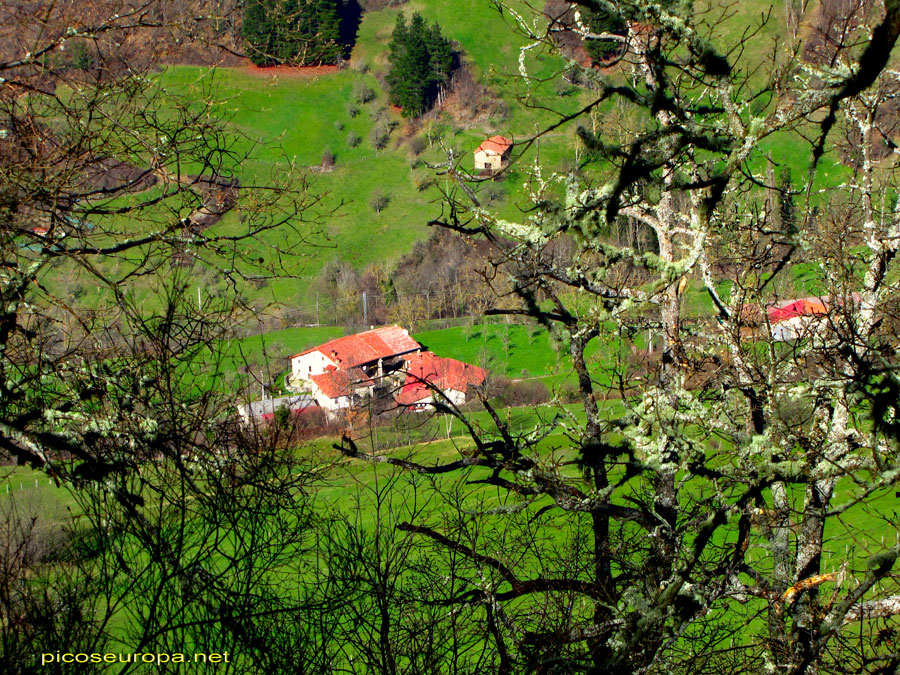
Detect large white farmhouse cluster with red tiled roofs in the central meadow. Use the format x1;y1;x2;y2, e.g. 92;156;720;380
239;325;487;421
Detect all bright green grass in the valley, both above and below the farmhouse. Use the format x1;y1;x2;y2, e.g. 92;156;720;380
7;0;900;672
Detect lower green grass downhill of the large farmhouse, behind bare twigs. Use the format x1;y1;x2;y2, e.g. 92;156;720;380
7;386;900;672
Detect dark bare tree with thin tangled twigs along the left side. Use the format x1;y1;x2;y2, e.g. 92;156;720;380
0;2;342;673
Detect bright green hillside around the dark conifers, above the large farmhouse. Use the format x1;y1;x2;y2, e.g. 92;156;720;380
144;0;580;312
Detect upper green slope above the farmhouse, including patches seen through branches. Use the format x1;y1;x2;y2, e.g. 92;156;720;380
42;0;850;324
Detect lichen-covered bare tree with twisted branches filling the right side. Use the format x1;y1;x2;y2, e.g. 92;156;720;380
340;2;900;673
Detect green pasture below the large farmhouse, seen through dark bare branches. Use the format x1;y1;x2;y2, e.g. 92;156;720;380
0;402;900;672
